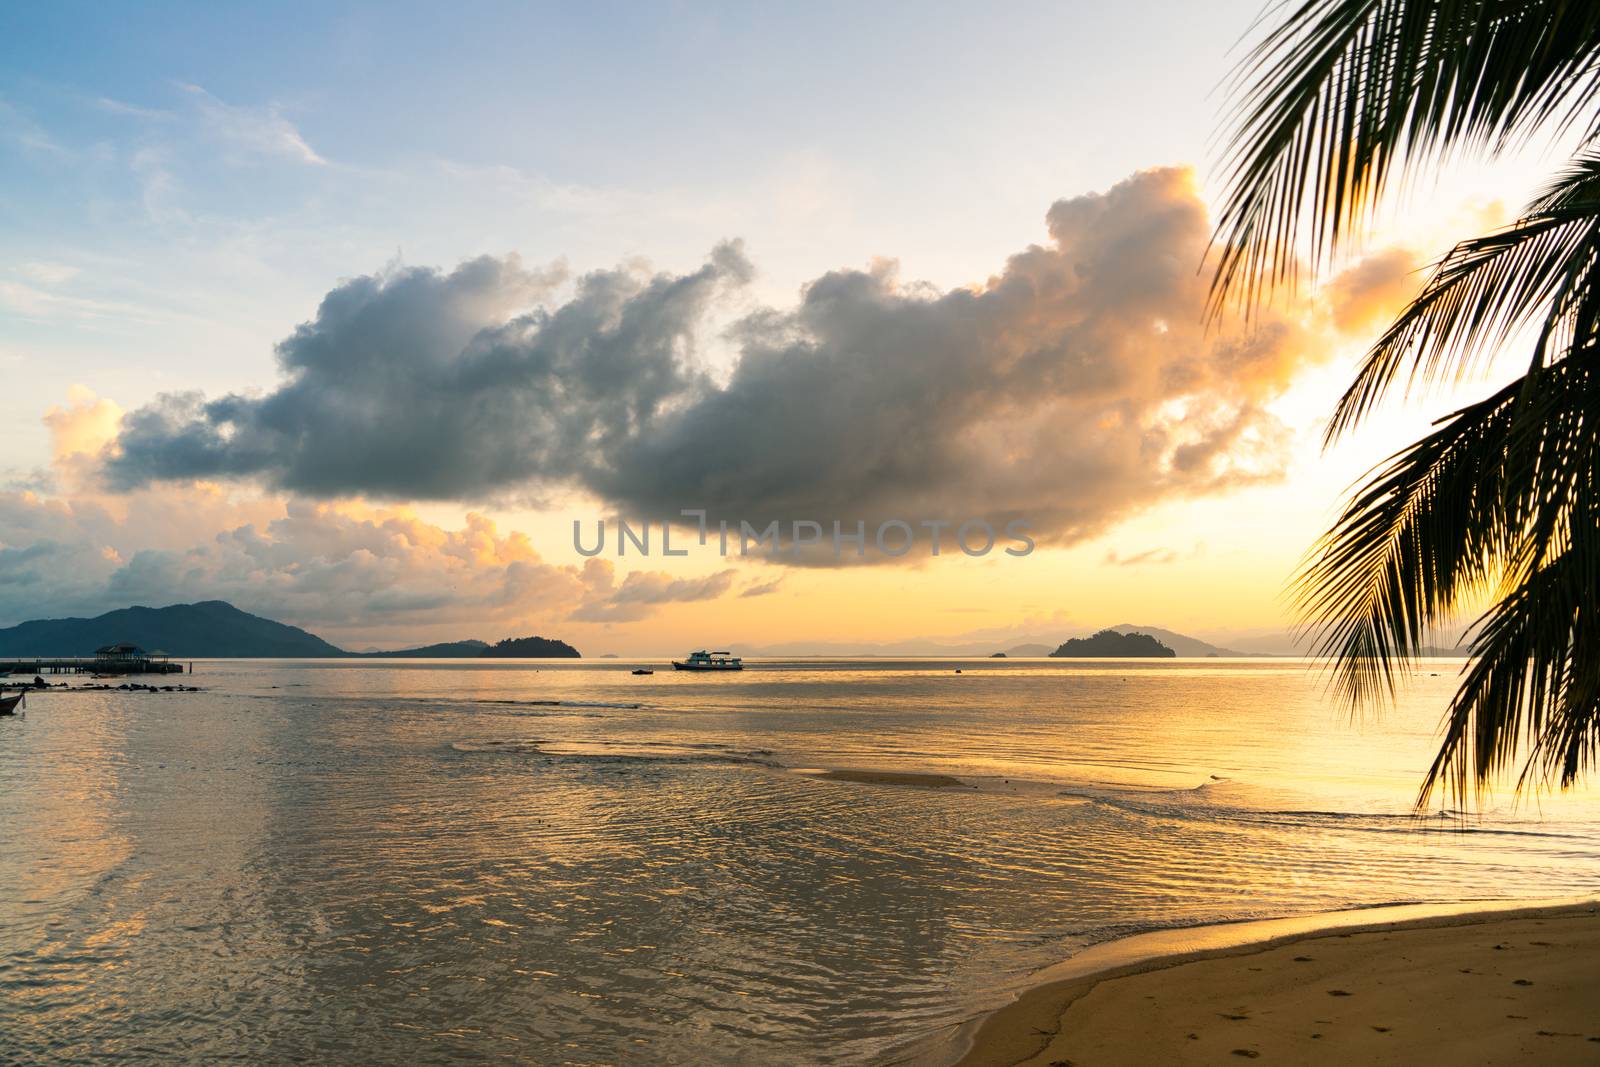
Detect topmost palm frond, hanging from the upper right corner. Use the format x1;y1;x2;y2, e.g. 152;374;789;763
1211;0;1600;309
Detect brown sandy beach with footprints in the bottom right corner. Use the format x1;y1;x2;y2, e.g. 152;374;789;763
960;904;1600;1067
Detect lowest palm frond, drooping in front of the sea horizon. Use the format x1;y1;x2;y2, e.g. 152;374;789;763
1299;348;1600;803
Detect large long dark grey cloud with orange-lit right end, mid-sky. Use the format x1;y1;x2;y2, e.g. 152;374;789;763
107;168;1376;558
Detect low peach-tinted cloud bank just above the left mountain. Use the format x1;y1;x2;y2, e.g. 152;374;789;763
0;485;733;643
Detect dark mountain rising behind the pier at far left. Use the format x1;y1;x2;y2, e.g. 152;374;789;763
0;600;346;659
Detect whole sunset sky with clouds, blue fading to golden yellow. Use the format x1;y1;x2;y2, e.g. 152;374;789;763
0;2;1557;654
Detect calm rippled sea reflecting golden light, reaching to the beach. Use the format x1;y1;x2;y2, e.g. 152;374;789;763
0;661;1600;1064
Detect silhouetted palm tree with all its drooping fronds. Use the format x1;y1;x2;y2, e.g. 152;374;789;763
1213;0;1600;805
